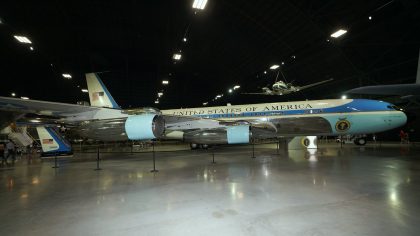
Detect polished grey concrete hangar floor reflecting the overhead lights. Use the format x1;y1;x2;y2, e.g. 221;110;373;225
0;144;420;235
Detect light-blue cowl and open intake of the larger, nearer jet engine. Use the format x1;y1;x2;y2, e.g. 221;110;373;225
124;114;165;140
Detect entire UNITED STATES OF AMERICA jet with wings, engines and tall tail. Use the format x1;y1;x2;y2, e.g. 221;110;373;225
0;73;407;148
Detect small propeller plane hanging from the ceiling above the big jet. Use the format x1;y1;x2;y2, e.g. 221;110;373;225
243;79;333;96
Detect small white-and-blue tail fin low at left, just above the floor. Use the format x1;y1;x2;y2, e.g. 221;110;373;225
36;126;71;153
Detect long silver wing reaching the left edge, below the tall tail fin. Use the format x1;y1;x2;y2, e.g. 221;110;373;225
0;97;101;117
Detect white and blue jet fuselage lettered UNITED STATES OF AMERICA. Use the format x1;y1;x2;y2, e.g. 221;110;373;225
162;99;407;136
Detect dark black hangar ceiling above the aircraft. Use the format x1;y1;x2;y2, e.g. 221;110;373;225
0;0;420;108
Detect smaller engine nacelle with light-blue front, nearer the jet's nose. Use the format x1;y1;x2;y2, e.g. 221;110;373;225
184;125;251;144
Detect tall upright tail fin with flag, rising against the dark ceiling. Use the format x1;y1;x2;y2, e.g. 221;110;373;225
86;73;120;109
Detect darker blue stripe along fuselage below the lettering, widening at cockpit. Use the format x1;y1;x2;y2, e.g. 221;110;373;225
193;99;395;119
